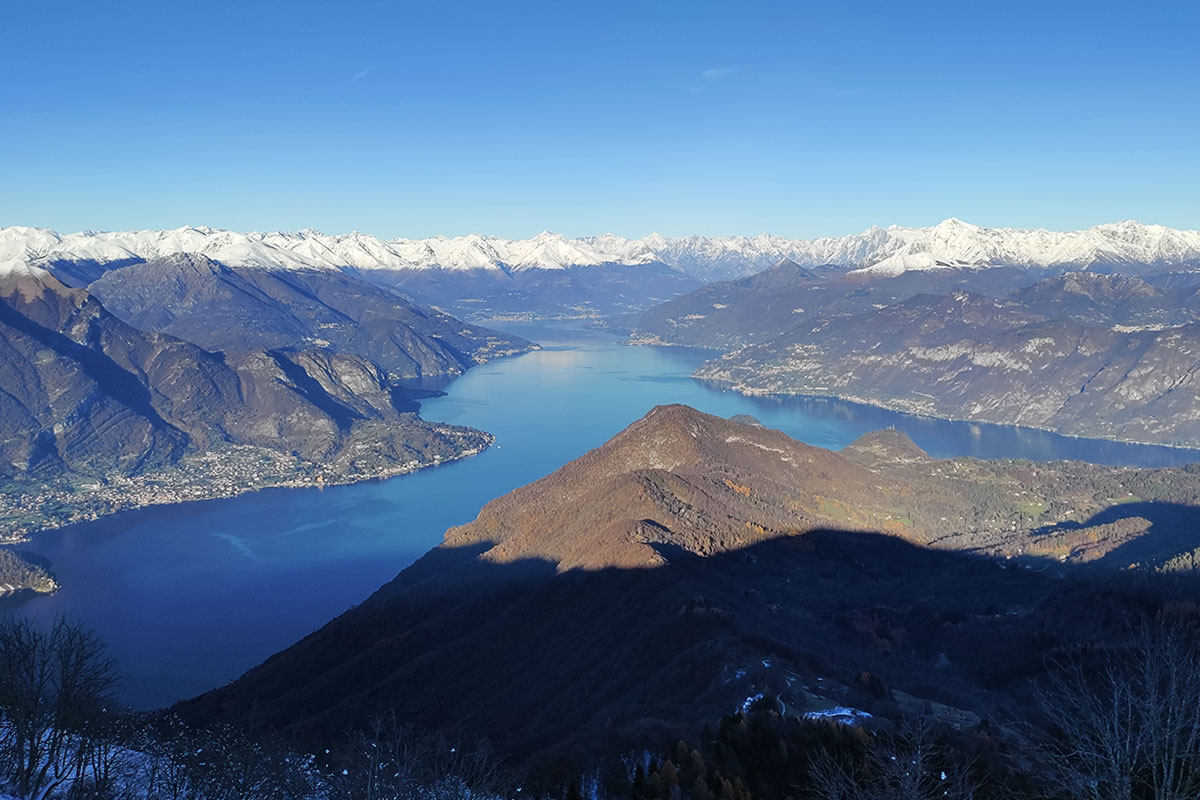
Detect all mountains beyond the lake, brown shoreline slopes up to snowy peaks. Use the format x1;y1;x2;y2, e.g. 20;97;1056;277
7;214;1200;551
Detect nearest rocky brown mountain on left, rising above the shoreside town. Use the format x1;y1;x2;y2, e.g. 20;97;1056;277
0;266;496;477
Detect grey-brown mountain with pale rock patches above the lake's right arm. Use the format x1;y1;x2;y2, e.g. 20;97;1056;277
695;273;1200;447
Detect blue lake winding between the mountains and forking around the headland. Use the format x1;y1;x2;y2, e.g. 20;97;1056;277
9;326;1200;708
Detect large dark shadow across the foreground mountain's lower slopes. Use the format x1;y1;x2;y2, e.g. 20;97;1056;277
175;530;1200;775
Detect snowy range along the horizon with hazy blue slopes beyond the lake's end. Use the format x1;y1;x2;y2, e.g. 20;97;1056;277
0;218;1200;321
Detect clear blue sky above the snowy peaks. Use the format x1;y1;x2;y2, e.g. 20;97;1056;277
0;0;1200;237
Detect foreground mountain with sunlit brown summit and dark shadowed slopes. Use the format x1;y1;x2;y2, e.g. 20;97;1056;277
176;405;1200;780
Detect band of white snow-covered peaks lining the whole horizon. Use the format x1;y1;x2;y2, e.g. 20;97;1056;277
0;218;1200;279
